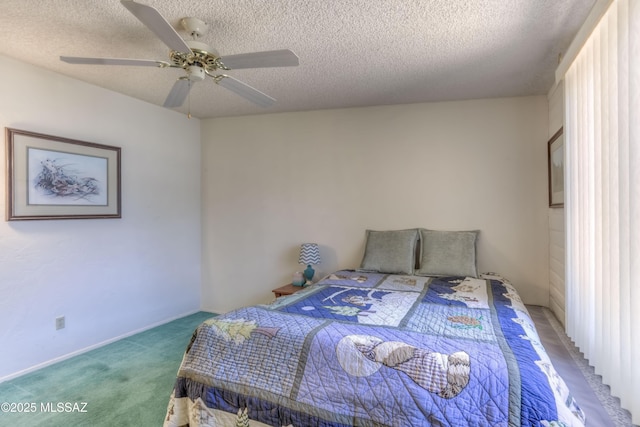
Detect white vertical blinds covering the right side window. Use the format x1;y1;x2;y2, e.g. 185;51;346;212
564;0;640;424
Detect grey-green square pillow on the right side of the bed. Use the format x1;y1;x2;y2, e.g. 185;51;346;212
415;228;479;277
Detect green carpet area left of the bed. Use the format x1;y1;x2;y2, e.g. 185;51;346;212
0;312;214;427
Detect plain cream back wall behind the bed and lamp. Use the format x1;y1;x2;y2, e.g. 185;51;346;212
202;96;549;312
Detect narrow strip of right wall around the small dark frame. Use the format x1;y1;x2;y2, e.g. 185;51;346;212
548;82;565;325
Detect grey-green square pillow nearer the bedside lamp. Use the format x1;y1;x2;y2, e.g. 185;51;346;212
360;228;418;274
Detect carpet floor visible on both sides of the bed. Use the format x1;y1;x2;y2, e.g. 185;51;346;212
0;306;632;427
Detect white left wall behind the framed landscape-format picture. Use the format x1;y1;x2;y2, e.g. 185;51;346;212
0;57;201;381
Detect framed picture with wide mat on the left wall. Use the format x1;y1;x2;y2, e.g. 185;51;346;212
5;128;122;221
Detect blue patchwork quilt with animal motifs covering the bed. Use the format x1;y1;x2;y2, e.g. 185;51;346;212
165;270;584;427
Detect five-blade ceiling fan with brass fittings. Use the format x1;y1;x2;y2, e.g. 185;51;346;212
60;0;298;108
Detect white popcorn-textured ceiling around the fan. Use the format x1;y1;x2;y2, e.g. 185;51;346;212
0;0;595;118
